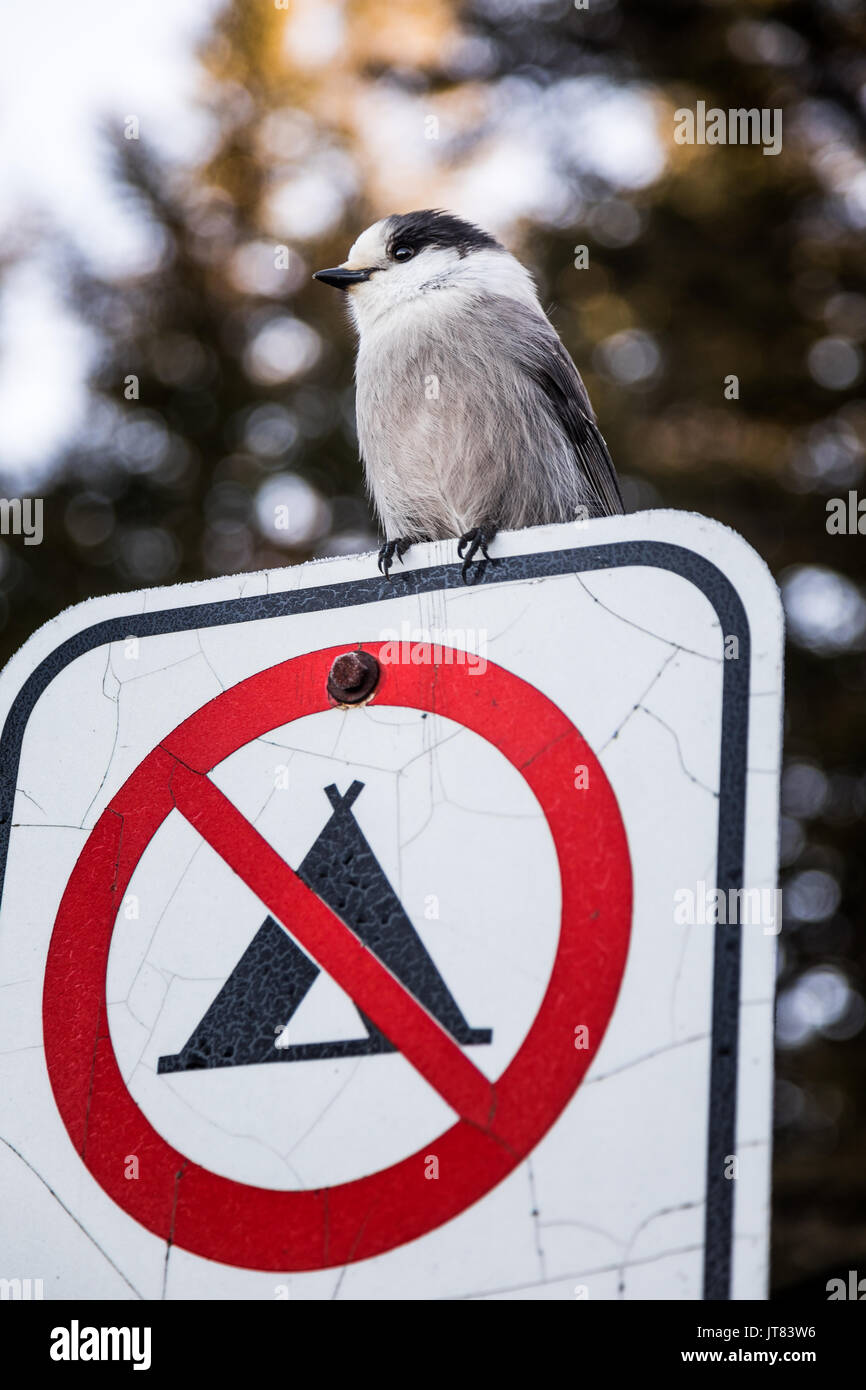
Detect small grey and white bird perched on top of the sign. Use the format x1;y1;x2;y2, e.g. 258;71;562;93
314;210;623;580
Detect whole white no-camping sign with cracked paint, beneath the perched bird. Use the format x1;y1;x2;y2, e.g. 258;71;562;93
0;512;781;1300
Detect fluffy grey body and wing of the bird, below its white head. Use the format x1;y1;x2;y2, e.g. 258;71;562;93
357;292;623;539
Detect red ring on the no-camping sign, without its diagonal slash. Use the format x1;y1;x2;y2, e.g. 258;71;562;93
43;644;631;1272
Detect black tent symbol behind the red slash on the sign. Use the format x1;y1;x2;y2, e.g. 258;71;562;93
157;781;493;1073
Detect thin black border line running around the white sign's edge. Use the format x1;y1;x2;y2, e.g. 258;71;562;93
0;541;751;1300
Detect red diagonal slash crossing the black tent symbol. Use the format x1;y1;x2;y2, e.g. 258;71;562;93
165;762;495;1130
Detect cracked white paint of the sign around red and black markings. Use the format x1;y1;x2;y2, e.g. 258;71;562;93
0;516;780;1298
